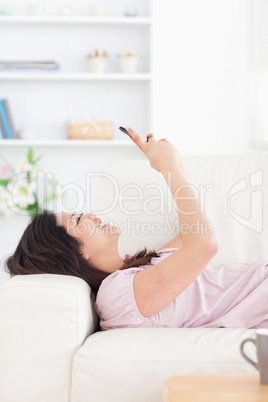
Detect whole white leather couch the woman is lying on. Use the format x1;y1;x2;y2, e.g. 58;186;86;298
0;153;268;402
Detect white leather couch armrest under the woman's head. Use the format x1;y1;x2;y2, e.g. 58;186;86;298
0;274;96;402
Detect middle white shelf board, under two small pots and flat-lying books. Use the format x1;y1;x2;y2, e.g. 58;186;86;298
0;71;151;82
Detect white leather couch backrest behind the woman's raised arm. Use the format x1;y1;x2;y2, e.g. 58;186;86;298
96;153;268;265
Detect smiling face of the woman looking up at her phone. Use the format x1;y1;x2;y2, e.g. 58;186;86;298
56;212;121;260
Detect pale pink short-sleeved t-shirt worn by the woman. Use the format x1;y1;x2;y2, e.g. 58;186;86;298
95;248;268;330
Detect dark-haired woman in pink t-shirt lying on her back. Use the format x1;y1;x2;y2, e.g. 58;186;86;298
7;128;268;329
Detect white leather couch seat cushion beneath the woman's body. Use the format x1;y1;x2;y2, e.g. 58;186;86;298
71;328;256;402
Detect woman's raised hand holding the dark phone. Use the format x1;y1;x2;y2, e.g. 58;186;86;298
126;127;183;173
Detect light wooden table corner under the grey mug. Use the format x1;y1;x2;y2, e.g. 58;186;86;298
163;374;268;402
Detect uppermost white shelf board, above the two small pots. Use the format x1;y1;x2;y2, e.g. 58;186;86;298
0;15;151;26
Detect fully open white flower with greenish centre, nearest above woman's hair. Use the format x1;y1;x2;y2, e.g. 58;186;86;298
7;177;36;208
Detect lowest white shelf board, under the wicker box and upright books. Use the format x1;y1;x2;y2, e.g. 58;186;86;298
0;139;136;149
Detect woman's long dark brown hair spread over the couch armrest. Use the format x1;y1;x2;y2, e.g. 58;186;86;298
6;211;158;295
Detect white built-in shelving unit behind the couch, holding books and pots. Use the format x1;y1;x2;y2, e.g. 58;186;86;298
0;0;152;147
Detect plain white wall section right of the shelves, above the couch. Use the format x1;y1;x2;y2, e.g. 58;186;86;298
152;0;252;154
